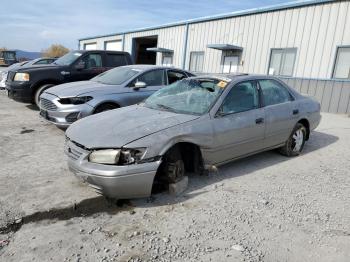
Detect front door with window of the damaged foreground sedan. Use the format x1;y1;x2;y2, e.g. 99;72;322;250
208;81;265;164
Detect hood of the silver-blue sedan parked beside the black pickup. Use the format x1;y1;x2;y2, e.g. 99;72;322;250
46;81;125;98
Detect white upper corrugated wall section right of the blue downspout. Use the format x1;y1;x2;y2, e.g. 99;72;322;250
186;1;350;78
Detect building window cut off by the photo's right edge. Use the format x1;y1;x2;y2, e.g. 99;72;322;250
333;46;350;79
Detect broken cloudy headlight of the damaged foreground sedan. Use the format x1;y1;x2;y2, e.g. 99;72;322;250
89;148;146;165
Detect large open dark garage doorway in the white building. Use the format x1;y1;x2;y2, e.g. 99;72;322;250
132;36;158;65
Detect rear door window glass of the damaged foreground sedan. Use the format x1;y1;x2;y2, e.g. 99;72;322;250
259;79;292;106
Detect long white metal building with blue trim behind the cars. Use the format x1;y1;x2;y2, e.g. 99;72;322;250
79;0;350;113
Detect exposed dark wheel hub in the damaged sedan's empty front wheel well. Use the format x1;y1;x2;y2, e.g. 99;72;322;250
164;148;185;183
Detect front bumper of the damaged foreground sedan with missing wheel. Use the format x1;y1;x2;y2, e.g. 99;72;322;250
65;141;161;199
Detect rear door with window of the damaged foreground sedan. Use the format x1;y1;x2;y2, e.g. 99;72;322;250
258;79;299;147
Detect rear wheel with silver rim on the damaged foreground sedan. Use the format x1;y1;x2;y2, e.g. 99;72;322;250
279;123;306;157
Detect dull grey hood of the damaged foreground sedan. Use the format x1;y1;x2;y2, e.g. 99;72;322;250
66;105;199;149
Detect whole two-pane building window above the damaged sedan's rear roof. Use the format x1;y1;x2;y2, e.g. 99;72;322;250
268;48;297;76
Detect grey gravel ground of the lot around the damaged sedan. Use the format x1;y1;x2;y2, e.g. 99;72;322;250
0;91;350;262
